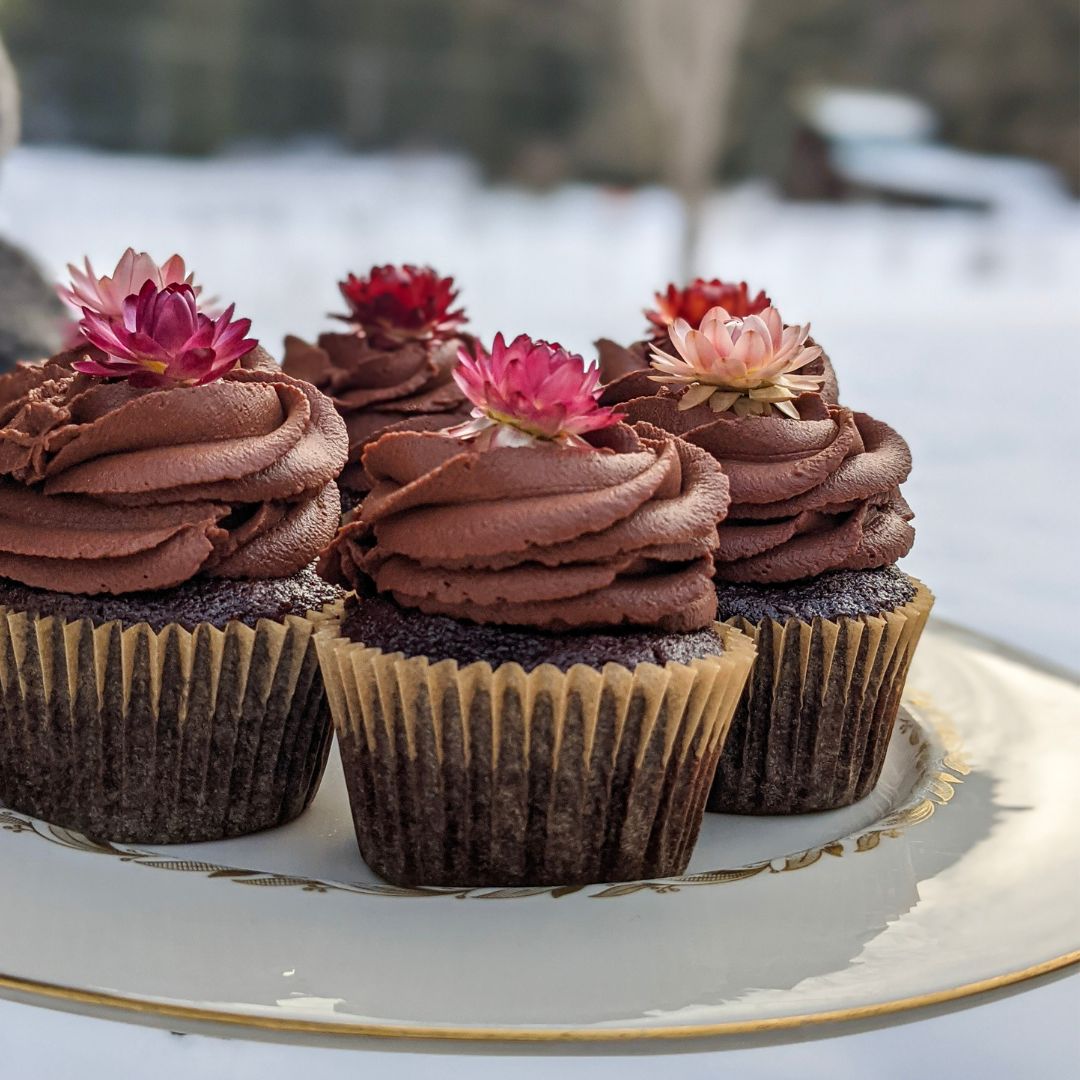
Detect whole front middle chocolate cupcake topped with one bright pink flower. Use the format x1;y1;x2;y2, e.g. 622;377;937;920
316;337;753;886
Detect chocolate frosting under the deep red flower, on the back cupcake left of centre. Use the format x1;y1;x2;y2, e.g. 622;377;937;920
282;333;471;491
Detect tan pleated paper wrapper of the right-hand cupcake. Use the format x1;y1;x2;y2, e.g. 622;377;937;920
708;578;934;814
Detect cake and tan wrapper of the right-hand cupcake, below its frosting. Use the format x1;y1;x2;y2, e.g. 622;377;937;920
707;567;932;814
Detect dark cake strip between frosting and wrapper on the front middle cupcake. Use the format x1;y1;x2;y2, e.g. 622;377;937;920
341;596;724;672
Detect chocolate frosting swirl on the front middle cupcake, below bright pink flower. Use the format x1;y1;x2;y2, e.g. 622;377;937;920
320;424;729;632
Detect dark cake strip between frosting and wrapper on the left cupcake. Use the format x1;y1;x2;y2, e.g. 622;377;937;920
0;565;341;631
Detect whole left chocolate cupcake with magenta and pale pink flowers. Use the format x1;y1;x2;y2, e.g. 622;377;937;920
0;253;347;843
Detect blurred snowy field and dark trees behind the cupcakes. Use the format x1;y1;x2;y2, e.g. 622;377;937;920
0;0;1080;667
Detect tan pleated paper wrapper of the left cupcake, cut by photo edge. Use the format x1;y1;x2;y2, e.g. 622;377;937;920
0;607;332;843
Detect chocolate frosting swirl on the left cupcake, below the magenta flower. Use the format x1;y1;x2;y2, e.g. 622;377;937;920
0;350;348;595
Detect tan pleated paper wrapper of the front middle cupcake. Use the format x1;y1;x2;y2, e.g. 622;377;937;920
315;625;754;887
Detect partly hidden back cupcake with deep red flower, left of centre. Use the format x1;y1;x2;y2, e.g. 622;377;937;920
282;266;472;510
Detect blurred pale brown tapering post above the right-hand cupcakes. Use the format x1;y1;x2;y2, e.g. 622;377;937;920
622;0;751;281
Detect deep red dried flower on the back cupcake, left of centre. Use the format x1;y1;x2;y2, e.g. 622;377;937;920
338;265;465;348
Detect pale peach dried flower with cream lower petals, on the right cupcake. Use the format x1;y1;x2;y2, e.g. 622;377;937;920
649;307;824;420
